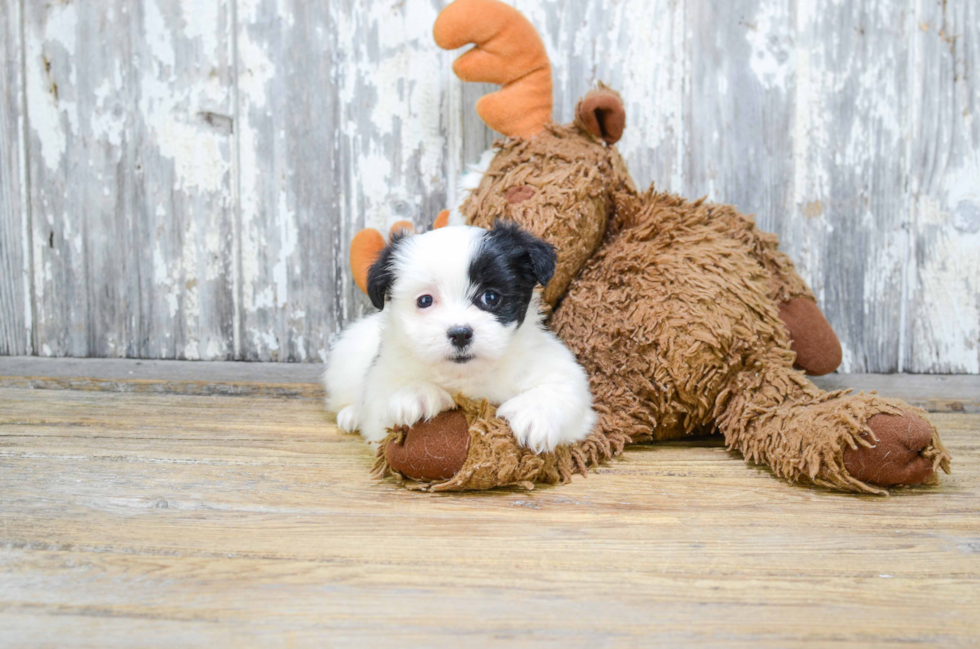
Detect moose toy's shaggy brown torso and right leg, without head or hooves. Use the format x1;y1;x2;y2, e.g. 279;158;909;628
552;185;946;493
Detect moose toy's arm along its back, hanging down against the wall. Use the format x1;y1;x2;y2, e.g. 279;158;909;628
708;205;842;376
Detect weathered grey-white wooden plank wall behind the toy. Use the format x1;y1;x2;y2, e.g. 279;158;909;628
0;0;980;373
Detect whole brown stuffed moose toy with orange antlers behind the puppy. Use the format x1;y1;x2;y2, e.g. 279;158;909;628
342;0;950;493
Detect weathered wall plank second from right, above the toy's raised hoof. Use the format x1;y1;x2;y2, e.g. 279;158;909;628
784;0;914;372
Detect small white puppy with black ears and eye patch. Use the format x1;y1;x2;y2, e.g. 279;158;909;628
323;222;596;453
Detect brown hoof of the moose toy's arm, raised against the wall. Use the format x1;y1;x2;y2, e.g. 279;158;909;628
779;297;842;376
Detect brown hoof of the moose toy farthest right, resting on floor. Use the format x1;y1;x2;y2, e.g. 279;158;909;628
844;412;934;487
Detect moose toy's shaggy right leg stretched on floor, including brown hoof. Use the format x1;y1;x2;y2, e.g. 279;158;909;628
717;361;950;493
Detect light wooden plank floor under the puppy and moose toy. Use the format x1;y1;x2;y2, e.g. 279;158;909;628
0;359;980;648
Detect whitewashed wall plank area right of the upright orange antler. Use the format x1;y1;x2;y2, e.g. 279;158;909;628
520;0;688;193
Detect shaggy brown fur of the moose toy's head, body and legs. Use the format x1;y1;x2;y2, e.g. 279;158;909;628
379;112;949;493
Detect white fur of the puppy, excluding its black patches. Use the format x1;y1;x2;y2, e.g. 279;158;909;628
324;226;596;452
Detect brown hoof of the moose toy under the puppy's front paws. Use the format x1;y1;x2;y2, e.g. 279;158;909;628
385;410;470;482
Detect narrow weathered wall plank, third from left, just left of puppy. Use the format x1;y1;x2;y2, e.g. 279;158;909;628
236;2;338;361
